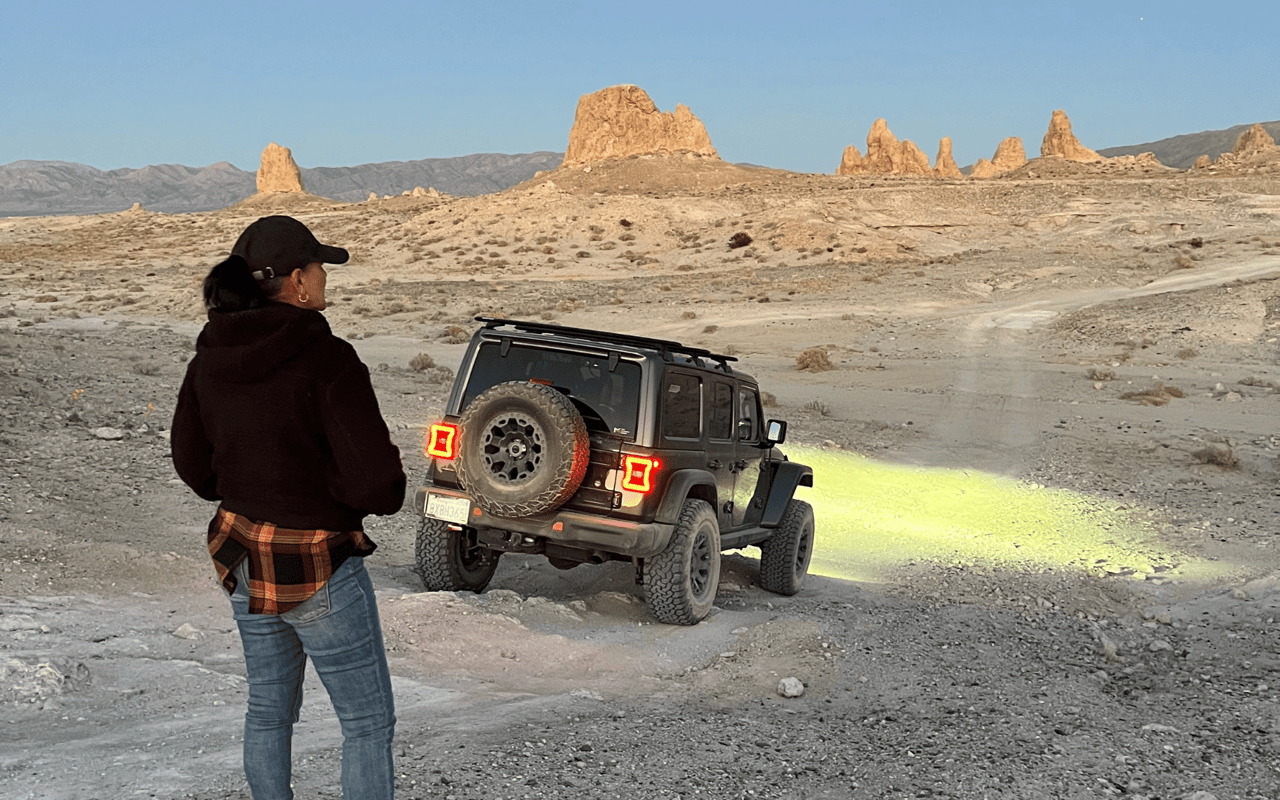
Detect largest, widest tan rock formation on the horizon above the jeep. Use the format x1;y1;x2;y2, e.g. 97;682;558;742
561;84;719;168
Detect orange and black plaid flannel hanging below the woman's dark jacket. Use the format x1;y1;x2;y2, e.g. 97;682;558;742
209;508;378;614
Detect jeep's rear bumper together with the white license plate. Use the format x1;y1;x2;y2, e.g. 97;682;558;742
413;486;676;558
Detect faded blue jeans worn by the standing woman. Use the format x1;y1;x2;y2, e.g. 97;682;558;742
230;556;396;800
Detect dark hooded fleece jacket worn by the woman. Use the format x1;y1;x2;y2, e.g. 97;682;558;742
170;303;406;531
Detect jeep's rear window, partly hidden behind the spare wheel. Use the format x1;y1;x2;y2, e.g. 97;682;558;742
460;342;640;438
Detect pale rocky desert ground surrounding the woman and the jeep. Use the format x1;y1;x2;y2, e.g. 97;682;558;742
0;157;1280;800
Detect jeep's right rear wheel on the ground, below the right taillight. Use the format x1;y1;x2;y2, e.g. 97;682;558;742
644;500;719;625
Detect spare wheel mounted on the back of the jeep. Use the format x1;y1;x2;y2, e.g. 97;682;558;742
458;381;591;517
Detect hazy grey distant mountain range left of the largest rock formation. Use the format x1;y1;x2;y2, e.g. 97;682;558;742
0;151;564;216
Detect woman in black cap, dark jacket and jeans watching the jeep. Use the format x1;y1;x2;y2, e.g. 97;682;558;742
170;216;404;800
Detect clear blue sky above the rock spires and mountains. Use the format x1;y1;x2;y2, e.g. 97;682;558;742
0;0;1280;173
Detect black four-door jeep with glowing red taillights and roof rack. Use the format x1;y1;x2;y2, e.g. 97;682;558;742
415;316;814;625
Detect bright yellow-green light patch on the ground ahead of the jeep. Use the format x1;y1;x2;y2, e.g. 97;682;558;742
785;445;1226;581
